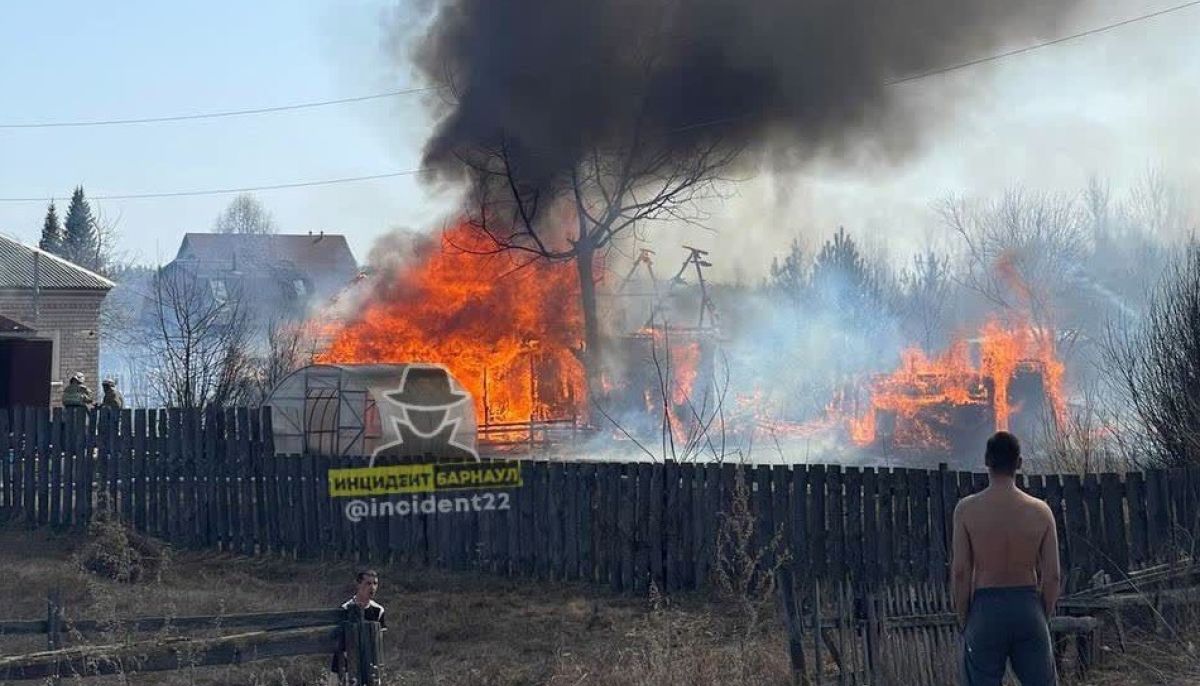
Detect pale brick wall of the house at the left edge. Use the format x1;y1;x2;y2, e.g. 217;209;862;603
0;290;107;405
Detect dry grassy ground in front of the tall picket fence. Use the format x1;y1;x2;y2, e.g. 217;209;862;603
0;525;1200;686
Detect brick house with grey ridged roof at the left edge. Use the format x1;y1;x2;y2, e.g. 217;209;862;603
0;236;113;407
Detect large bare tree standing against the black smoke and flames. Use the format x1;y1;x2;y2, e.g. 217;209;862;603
449;37;740;412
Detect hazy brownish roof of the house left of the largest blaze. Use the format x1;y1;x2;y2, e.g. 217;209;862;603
175;234;358;273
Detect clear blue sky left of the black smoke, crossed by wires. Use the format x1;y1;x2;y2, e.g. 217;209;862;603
0;0;448;261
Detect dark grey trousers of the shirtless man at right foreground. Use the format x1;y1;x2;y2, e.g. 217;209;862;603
962;586;1058;686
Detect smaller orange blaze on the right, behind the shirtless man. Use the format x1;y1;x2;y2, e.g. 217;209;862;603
838;320;1066;450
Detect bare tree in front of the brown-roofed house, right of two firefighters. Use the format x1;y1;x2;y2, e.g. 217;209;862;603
146;267;252;408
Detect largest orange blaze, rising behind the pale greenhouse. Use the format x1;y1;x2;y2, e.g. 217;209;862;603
318;224;587;425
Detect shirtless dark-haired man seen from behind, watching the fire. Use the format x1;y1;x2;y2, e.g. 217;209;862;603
950;432;1060;686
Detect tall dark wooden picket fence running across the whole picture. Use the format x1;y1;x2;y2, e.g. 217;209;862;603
0;408;1200;594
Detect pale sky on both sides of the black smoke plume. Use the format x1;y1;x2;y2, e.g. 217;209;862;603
0;0;1200;278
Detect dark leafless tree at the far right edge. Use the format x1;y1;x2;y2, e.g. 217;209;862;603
1105;242;1200;467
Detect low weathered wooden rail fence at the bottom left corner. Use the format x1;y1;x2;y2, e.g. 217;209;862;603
0;601;382;685
